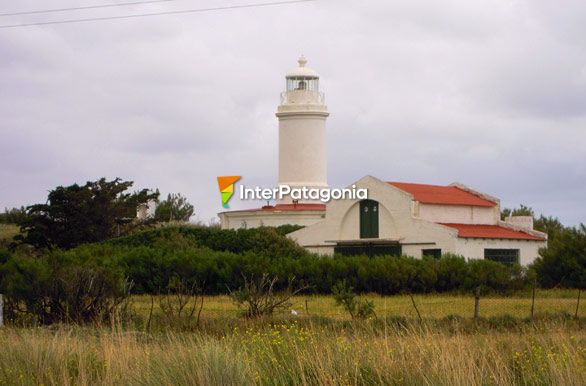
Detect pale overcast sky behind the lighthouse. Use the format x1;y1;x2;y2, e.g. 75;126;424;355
0;0;586;225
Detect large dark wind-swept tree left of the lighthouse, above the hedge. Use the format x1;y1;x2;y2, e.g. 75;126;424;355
18;178;158;249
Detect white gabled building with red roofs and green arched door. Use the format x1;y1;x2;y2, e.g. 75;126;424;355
290;176;547;265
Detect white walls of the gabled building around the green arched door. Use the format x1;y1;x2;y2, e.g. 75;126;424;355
289;176;546;265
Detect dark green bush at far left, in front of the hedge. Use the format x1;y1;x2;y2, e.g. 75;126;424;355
0;250;129;324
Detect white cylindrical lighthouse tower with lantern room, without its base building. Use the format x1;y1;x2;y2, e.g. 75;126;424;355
276;56;329;204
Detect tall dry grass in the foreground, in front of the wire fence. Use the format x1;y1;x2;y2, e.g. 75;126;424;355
0;320;586;385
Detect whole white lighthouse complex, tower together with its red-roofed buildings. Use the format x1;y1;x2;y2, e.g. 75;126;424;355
219;58;547;265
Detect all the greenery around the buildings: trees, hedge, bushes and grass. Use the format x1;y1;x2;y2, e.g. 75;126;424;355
0;179;586;385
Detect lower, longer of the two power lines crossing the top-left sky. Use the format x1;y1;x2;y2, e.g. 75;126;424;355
0;0;317;29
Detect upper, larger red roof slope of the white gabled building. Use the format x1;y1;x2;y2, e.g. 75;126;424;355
389;182;496;207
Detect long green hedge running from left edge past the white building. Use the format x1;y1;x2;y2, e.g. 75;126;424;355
0;226;532;323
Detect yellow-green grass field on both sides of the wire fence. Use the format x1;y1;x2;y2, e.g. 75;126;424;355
0;291;586;385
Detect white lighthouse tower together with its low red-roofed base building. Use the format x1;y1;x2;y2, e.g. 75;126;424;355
218;56;329;229
